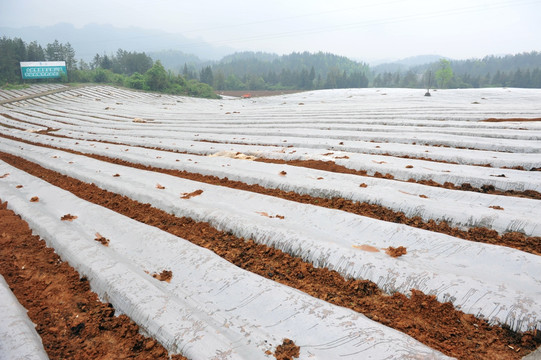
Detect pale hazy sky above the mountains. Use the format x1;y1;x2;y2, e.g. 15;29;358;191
0;0;541;61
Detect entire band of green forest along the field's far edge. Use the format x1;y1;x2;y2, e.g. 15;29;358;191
0;37;541;91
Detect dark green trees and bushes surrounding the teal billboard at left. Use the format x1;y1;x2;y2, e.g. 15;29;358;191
0;36;217;98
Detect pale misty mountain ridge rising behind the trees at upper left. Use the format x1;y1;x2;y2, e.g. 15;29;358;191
0;23;234;61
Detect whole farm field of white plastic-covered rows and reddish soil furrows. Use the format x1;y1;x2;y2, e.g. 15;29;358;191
0;85;541;360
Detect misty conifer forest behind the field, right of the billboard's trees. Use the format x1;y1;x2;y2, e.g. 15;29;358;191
181;51;541;91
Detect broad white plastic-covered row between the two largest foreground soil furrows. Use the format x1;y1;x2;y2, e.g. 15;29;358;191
0;163;452;359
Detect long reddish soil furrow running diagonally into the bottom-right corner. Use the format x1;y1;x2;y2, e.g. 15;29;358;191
1;155;536;359
